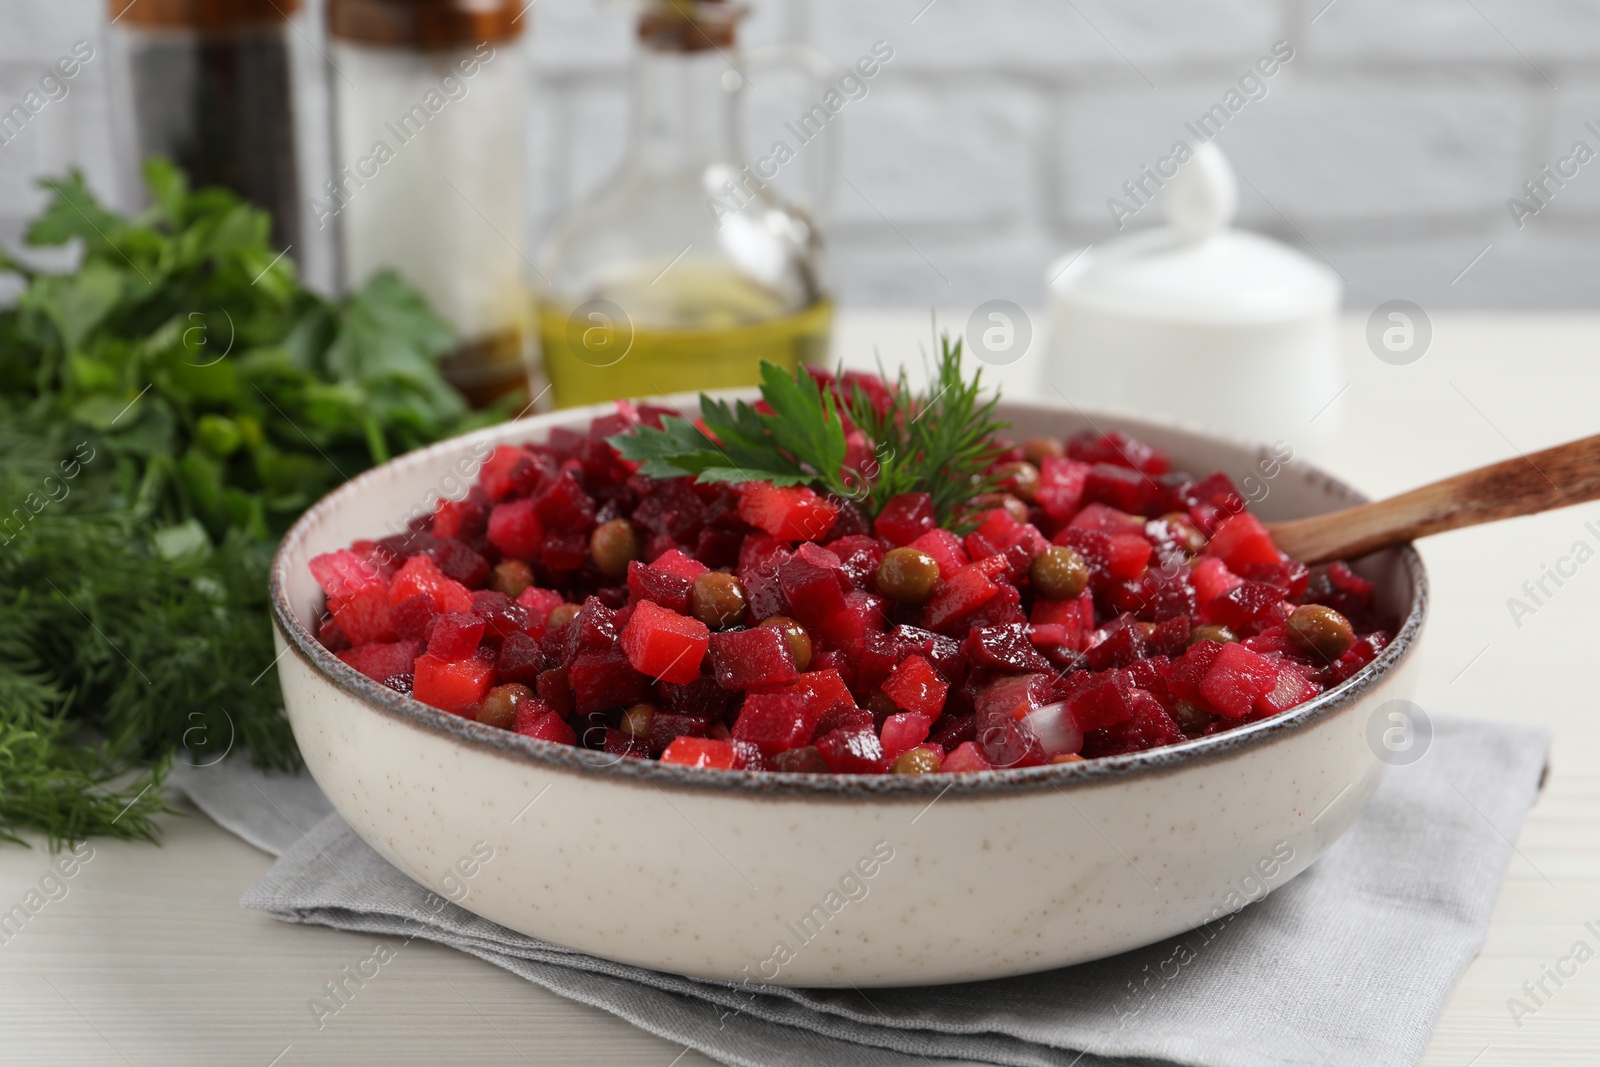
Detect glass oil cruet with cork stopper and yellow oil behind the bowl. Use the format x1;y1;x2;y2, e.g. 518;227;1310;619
536;0;832;406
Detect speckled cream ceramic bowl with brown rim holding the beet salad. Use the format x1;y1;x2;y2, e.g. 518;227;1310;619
272;403;1427;987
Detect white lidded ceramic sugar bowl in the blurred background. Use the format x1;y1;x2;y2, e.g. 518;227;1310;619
1048;144;1344;450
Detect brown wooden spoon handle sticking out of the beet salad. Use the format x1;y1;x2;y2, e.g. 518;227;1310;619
1267;434;1600;563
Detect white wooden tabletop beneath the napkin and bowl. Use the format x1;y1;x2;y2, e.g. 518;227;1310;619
0;312;1600;1067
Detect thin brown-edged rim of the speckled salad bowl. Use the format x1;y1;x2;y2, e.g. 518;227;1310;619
267;399;1429;806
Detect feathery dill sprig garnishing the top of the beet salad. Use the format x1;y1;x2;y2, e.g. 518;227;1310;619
846;334;1008;526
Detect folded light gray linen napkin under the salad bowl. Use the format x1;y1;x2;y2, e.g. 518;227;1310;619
178;720;1549;1067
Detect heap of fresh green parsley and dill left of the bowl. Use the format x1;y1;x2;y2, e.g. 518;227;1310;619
0;160;499;840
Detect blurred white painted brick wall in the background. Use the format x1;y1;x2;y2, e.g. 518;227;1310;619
0;0;1600;309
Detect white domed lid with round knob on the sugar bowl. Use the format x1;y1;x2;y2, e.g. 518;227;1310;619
1050;142;1342;325
